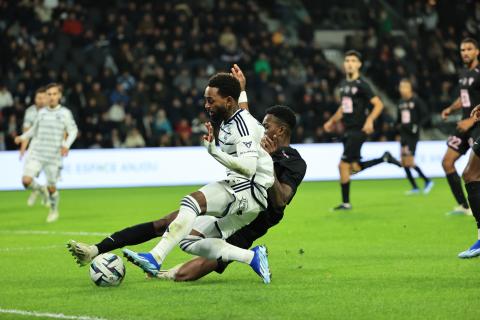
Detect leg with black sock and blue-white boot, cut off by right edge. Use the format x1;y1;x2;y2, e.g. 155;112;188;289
458;149;480;258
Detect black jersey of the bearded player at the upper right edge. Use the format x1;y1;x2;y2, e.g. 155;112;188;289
458;67;480;119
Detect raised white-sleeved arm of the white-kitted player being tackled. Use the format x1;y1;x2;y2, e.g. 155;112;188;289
203;122;257;178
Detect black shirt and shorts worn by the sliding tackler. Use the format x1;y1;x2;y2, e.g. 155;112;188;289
227;147;307;249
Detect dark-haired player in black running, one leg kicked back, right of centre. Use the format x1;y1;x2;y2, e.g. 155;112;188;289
324;50;401;210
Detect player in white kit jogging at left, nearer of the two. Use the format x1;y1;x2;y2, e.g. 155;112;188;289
15;83;78;222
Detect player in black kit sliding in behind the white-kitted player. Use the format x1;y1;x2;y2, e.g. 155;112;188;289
67;102;307;281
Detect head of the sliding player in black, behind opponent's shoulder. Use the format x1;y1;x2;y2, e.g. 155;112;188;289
262;106;297;139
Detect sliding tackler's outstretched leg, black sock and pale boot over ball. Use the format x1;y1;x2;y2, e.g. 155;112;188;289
67;211;178;266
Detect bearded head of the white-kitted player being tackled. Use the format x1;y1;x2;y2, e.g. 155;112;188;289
205;73;241;121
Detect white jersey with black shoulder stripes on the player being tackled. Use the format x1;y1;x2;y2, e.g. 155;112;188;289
218;109;275;189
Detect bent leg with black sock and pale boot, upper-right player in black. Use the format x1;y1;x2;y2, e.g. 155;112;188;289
442;136;470;214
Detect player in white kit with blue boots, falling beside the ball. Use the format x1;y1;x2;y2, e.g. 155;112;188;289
123;73;274;283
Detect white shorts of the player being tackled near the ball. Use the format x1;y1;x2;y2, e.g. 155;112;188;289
197;178;267;239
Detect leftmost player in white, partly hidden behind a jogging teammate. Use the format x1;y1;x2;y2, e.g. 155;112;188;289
20;87;49;207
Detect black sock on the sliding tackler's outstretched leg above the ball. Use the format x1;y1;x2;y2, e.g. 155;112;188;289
96;222;157;254
